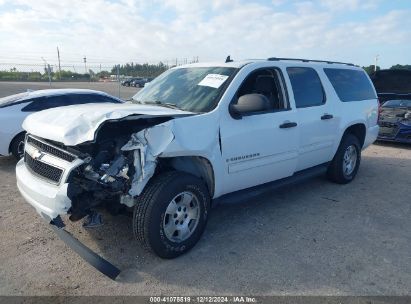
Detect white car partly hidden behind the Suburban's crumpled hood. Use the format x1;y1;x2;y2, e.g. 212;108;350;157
0;89;124;159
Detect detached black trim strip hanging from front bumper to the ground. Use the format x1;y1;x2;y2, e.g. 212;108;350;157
47;216;121;280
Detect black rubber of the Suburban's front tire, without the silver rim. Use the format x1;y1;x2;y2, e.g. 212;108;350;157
133;171;210;259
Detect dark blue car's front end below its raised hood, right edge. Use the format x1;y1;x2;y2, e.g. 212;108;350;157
378;99;411;143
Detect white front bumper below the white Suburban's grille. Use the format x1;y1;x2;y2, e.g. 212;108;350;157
16;159;71;219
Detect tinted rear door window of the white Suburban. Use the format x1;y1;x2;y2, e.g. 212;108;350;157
287;67;325;108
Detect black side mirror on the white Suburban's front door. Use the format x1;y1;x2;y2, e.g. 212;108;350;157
229;94;270;119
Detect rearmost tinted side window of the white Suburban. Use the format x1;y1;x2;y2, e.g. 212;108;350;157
324;68;377;102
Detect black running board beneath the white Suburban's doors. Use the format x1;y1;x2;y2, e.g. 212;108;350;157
213;162;329;207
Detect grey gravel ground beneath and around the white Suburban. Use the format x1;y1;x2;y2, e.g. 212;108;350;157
0;144;411;295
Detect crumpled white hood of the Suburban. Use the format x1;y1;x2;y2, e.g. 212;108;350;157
23;103;193;146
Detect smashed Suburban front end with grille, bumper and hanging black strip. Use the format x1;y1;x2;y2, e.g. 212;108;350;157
16;121;180;279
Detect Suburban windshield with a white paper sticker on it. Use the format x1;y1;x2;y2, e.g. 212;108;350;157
133;67;236;112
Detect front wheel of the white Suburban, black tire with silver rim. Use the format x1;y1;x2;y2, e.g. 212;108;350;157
133;171;210;259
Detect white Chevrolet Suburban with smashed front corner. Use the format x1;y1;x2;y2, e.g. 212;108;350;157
16;58;378;278
